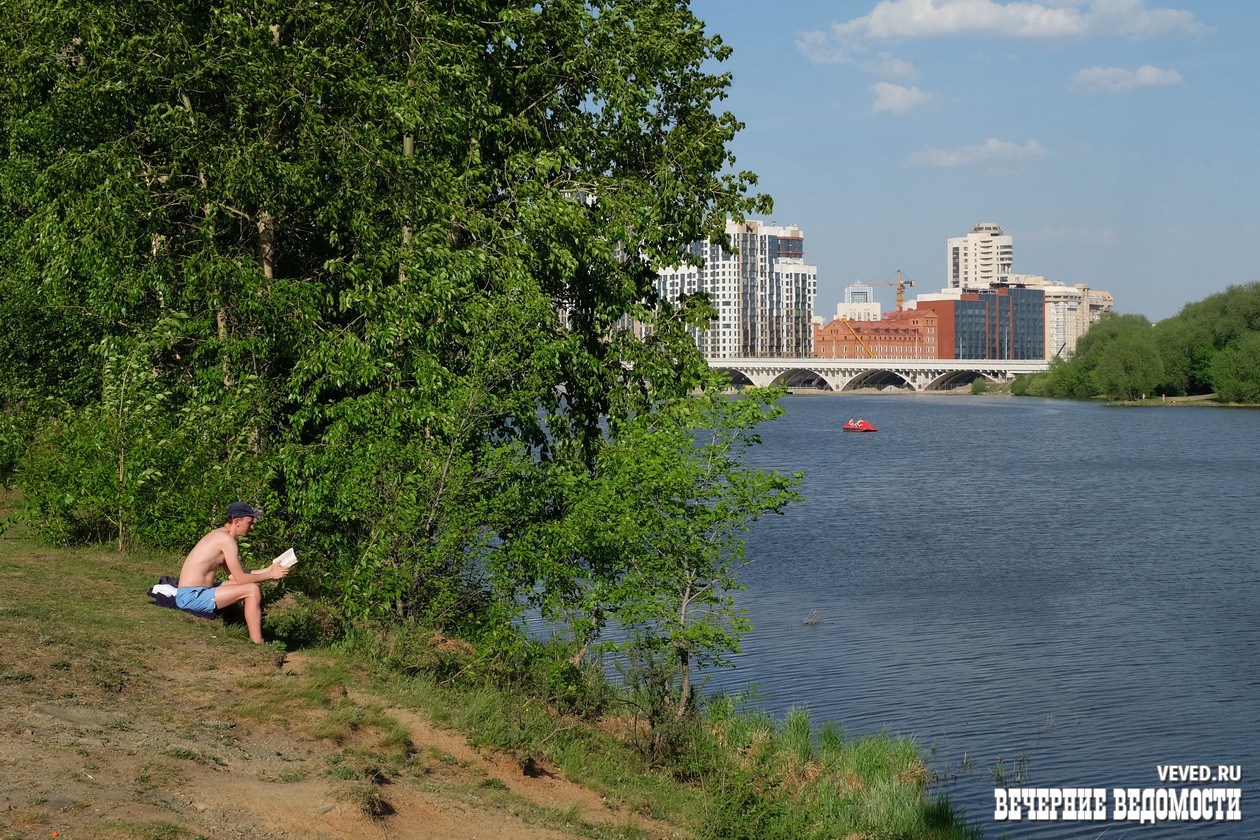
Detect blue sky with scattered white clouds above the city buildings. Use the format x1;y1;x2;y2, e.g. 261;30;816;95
692;0;1260;321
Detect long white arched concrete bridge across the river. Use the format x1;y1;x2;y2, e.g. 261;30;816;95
708;359;1050;390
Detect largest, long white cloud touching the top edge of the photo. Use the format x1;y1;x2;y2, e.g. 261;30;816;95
796;0;1208;63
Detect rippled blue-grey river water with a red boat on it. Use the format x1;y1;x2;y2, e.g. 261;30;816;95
708;394;1260;839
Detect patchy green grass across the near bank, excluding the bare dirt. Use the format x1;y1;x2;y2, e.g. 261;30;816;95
0;498;982;840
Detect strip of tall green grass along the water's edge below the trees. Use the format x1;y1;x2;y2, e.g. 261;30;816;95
344;640;979;840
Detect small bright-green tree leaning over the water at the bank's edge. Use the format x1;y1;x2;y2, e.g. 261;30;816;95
503;380;799;723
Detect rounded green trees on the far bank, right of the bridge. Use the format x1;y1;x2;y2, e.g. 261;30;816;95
1012;283;1260;403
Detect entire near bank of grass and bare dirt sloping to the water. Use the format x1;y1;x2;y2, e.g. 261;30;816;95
0;516;975;840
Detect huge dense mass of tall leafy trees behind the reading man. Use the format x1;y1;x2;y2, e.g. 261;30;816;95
0;0;777;649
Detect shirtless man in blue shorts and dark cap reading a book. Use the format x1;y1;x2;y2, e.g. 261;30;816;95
175;501;289;645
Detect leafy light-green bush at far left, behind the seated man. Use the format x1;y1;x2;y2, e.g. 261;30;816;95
13;351;271;550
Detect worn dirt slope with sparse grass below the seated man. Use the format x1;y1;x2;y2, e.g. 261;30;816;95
0;541;684;840
